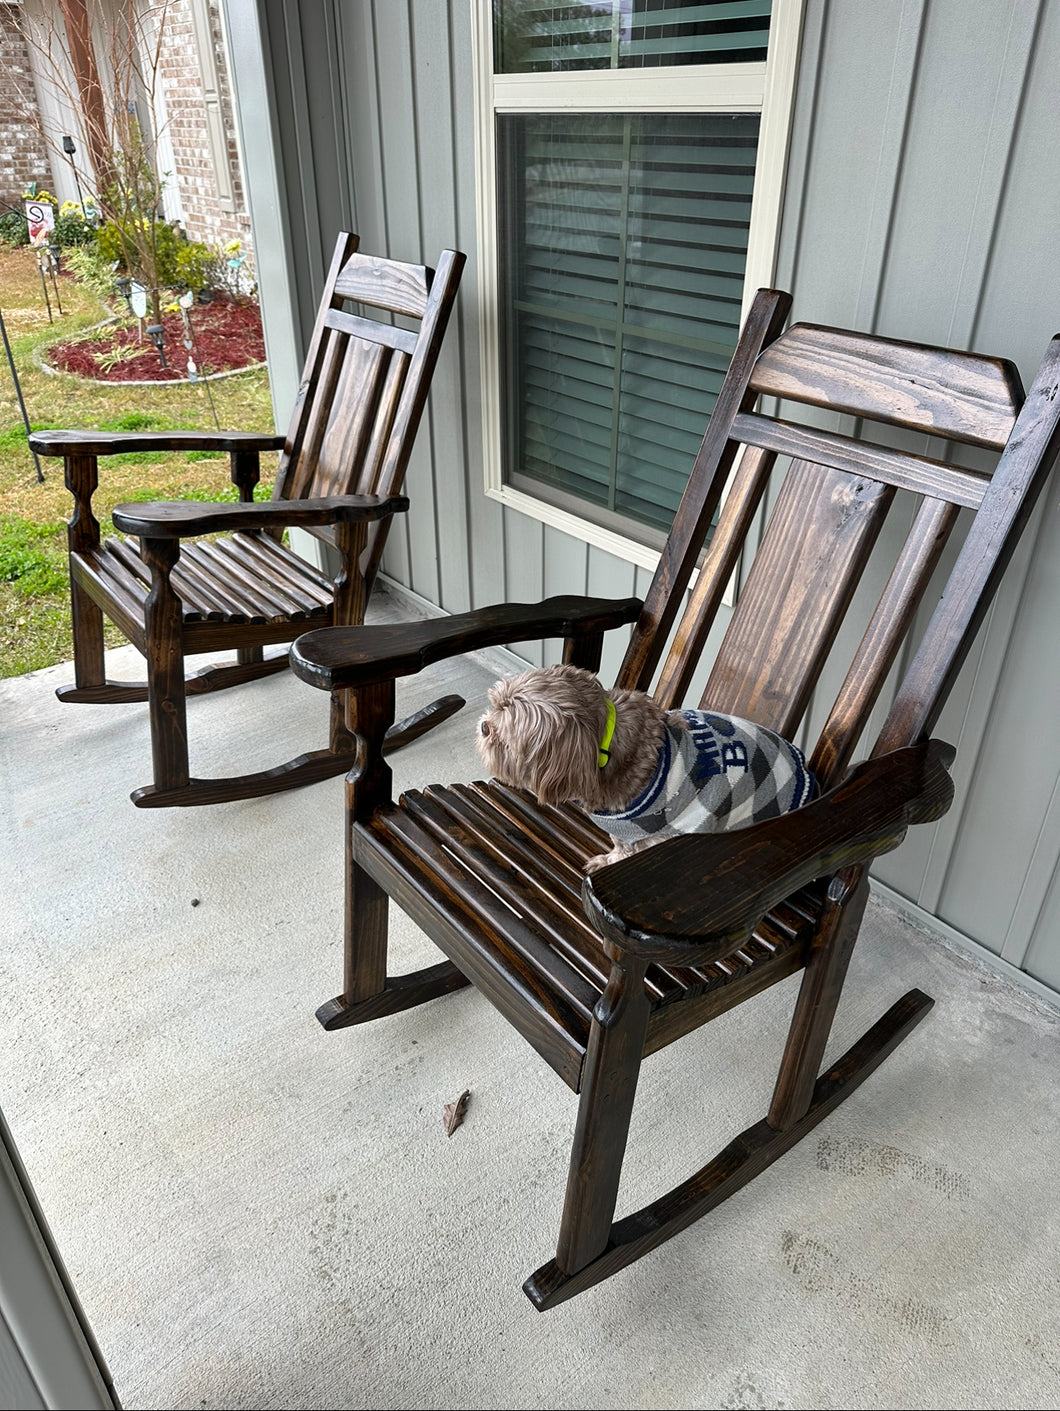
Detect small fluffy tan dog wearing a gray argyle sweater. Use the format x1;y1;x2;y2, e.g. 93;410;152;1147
478;666;816;872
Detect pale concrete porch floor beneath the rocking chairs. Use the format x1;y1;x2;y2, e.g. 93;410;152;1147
0;595;1060;1408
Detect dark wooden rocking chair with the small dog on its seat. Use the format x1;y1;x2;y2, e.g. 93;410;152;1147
292;291;1060;1309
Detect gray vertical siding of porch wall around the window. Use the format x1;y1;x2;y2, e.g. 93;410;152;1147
229;0;1060;989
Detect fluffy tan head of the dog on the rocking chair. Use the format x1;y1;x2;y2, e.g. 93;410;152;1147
478;666;607;803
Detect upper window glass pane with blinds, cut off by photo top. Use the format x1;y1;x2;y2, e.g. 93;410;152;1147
494;0;771;73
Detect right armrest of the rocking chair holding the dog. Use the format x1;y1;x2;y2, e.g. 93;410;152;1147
582;739;956;965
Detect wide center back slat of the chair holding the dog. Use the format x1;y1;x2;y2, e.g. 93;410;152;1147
700;461;895;735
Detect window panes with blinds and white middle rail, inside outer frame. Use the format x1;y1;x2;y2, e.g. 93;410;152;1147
491;0;771;543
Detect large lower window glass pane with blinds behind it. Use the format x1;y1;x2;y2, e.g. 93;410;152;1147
498;113;758;528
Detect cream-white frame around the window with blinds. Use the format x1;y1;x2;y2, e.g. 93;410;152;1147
471;0;805;571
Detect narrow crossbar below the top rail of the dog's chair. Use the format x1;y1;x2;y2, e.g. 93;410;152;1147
733;412;989;509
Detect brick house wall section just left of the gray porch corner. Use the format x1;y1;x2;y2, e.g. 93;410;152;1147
161;0;250;251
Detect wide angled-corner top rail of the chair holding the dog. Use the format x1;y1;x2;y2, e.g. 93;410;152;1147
751;323;1023;450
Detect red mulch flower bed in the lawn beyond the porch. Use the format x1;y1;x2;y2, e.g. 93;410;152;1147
47;298;265;382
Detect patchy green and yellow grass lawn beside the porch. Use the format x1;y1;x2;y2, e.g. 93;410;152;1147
0;246;274;676
